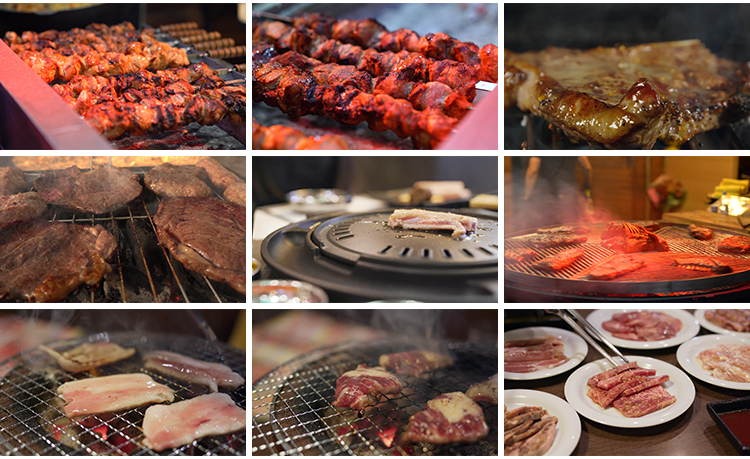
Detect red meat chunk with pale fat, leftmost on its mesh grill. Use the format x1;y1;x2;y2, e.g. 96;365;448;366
333;364;403;410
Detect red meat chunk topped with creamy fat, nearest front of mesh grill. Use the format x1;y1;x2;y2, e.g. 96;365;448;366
403;392;490;444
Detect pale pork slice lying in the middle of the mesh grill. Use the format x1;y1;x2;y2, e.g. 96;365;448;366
57;373;174;418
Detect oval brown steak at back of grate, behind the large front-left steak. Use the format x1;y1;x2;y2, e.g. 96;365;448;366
34;166;142;214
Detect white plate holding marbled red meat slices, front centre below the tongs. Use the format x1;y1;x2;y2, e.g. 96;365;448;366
565;355;695;428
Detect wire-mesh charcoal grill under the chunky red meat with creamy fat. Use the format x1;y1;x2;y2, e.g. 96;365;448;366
252;339;498;456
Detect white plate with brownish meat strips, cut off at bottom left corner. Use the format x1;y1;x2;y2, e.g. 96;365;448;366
503;389;581;456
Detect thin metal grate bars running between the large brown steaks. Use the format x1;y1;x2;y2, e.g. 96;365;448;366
6;157;245;303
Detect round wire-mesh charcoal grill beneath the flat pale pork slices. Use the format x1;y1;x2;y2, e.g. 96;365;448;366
0;332;247;456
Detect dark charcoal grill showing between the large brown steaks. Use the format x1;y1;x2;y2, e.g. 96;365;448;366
1;158;246;303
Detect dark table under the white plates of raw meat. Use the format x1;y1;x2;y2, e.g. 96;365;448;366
504;309;750;456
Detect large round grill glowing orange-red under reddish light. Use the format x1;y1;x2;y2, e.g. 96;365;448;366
505;222;750;301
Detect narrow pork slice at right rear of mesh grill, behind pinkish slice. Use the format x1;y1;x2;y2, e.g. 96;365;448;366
148;351;250;392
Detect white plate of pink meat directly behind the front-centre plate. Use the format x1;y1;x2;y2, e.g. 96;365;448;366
586;309;701;349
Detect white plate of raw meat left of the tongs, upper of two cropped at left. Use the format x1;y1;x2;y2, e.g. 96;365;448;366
503;327;589;380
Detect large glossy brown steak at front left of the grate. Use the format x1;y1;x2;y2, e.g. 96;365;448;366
0;219;117;302
